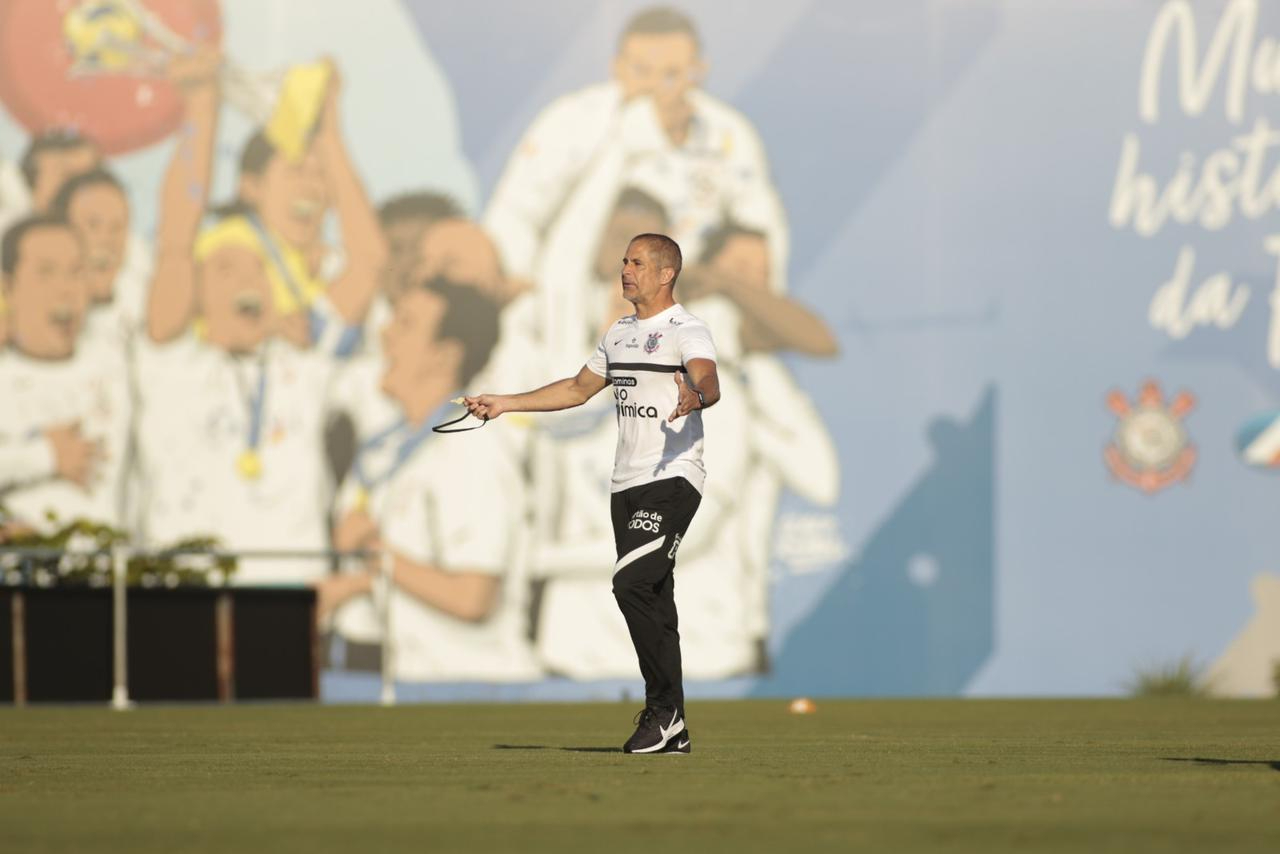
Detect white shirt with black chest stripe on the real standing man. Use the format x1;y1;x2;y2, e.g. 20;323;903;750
586;302;716;493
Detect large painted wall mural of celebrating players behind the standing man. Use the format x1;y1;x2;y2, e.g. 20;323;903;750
0;0;1280;698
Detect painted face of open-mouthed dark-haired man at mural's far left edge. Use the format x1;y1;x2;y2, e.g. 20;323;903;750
5;225;88;360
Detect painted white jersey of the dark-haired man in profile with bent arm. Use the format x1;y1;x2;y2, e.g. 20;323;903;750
334;365;541;681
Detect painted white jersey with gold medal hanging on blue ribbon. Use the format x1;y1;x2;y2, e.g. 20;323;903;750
136;333;335;584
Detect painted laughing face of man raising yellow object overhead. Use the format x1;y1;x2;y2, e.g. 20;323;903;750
241;150;329;248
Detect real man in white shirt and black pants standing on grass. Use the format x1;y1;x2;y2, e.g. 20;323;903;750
466;234;719;753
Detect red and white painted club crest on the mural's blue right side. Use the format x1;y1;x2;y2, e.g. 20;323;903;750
1102;380;1196;494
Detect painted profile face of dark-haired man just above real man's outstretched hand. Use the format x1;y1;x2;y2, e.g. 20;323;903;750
381;288;462;401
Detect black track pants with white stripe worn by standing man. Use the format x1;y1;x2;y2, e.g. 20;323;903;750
609;478;703;716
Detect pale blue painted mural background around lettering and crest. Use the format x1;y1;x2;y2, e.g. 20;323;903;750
373;0;1280;695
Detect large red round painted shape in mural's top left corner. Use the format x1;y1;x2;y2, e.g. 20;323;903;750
0;0;221;155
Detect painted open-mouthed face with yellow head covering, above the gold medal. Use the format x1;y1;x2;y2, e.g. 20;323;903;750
197;245;276;353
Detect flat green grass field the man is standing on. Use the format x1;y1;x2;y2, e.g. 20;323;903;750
0;700;1280;854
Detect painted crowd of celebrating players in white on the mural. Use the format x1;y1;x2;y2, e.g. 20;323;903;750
0;9;840;681
